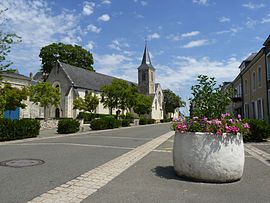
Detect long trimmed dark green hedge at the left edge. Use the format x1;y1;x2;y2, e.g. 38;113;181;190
0;118;40;141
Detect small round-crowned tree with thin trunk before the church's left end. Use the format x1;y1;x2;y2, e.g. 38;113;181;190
30;82;60;120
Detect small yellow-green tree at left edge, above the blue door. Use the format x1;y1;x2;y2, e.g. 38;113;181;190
0;84;28;118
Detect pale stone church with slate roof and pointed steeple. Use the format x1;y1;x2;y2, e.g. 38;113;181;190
46;45;163;121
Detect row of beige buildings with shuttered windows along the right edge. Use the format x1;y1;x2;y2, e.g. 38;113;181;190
228;37;270;123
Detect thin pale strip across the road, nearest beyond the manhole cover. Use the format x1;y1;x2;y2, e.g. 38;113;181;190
13;142;135;150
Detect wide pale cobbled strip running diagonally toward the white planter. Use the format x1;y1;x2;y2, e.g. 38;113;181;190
29;131;174;203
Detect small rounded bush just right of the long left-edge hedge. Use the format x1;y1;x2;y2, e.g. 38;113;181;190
57;118;80;134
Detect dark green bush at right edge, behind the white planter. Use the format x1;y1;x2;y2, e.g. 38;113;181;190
243;119;270;142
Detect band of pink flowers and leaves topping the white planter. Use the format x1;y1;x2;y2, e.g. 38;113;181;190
172;113;250;135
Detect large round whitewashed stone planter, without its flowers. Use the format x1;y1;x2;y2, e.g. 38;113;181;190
173;132;245;183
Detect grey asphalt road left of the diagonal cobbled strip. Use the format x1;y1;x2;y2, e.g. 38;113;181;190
0;124;170;203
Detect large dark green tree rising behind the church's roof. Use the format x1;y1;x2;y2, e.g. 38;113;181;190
39;43;94;74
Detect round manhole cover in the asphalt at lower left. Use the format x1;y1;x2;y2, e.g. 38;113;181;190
0;159;45;168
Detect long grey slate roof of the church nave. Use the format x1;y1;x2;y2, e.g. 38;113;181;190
59;62;137;91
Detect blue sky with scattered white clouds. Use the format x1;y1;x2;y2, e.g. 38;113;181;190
0;0;270;112
